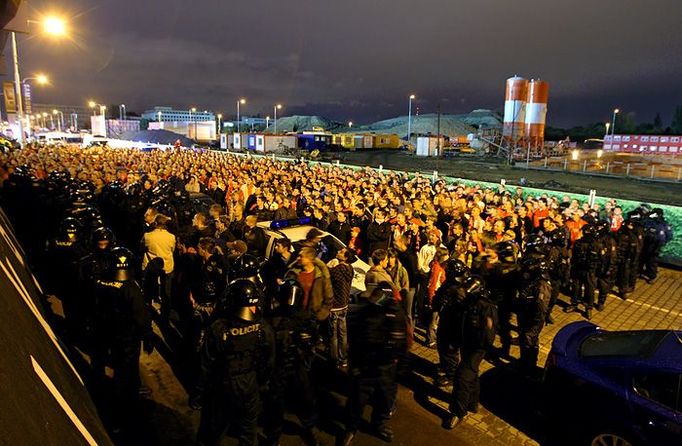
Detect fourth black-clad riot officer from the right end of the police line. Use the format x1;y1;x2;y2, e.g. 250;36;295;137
564;224;599;319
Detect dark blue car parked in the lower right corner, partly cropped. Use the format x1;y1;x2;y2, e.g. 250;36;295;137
543;321;682;446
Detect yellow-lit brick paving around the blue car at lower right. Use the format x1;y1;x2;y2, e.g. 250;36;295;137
412;269;682;445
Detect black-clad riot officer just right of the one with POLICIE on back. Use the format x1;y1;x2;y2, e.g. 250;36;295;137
264;279;317;445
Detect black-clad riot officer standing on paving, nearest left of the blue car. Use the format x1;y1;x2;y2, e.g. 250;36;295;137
444;276;497;429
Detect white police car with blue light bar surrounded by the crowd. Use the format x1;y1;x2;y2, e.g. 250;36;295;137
257;217;369;295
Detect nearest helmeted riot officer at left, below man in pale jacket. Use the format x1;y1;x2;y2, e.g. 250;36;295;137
92;247;153;421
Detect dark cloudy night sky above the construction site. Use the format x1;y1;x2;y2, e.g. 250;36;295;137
8;0;682;126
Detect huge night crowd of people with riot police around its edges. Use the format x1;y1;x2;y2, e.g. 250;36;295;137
0;147;672;445
